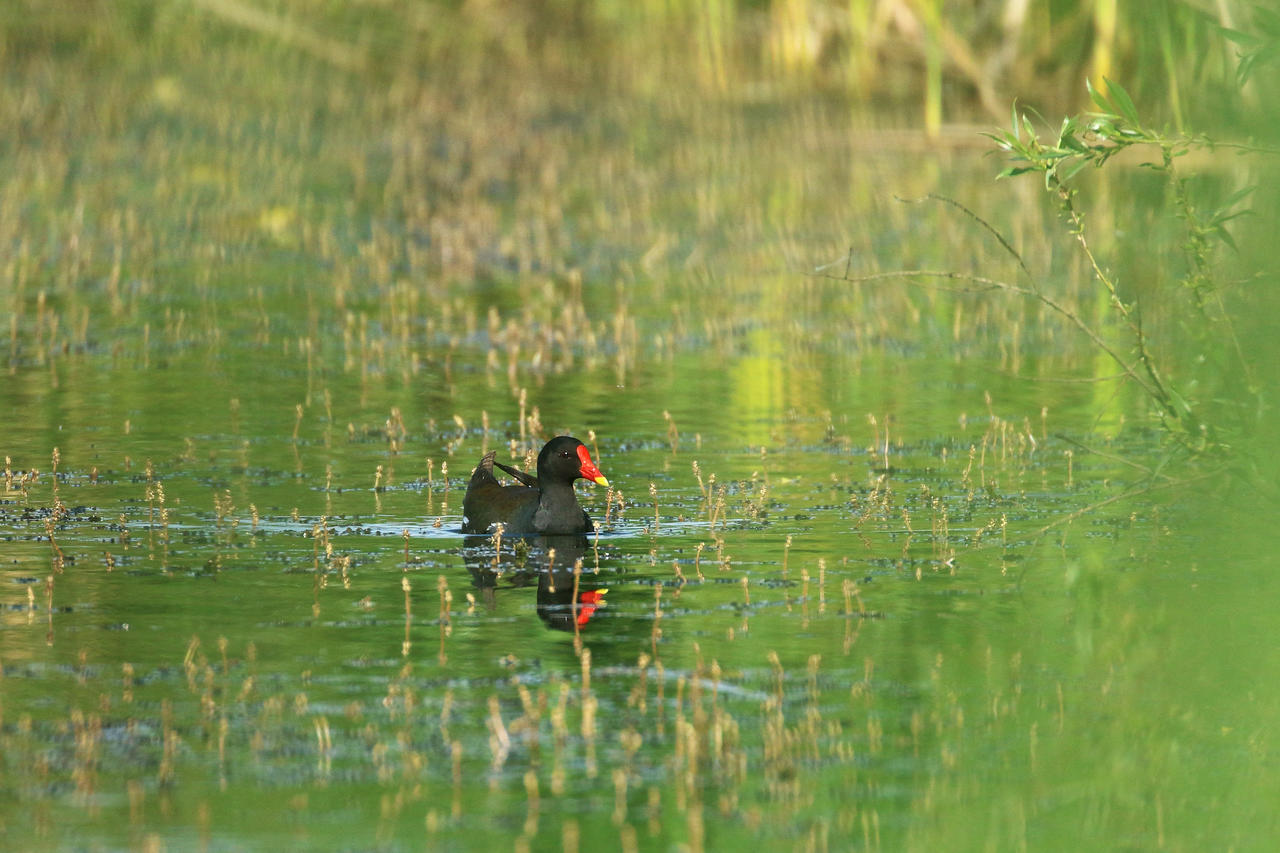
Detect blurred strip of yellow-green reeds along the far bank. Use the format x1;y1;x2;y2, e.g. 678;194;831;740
0;0;1280;136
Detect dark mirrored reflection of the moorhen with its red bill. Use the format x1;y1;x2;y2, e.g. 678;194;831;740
462;535;607;631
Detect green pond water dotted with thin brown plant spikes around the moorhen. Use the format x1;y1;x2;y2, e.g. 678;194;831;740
0;8;1280;850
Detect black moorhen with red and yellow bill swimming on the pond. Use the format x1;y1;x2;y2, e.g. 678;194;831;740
462;435;609;535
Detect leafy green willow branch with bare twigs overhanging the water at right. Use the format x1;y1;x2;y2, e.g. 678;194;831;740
815;73;1277;474
